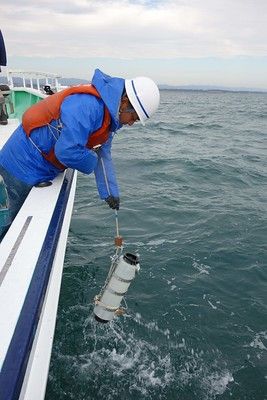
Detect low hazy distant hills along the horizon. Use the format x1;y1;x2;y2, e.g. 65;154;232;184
0;76;267;93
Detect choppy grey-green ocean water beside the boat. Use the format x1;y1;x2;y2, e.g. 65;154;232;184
46;91;267;400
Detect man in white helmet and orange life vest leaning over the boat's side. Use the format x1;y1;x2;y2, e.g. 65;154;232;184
0;69;160;236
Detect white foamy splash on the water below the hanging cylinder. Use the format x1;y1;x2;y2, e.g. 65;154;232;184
79;313;233;400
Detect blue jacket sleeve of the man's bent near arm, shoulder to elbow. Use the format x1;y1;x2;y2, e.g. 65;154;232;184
55;94;104;174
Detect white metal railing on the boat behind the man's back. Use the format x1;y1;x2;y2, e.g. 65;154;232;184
7;70;62;92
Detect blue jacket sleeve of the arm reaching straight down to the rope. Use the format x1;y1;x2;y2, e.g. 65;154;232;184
95;136;119;200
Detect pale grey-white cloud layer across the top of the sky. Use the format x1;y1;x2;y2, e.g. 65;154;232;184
0;0;267;59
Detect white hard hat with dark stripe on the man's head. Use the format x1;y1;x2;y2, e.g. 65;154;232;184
125;76;160;125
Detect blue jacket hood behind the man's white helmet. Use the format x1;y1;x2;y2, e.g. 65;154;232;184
92;69;125;131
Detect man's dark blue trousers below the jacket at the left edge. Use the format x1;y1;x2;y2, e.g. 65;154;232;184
0;165;32;241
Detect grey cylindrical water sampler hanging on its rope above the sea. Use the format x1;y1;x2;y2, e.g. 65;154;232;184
94;210;140;323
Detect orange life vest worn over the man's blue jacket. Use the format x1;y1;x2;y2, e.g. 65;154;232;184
22;85;111;170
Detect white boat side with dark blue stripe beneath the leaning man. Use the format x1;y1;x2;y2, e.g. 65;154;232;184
0;78;77;400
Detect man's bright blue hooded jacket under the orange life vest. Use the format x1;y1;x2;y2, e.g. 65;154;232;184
0;69;124;199
